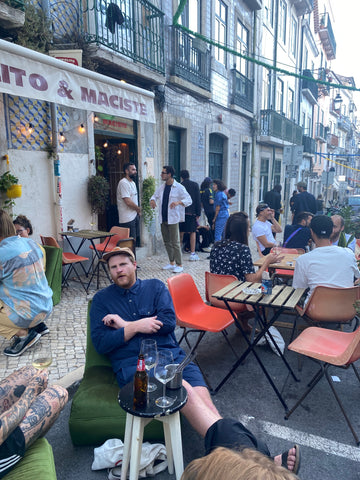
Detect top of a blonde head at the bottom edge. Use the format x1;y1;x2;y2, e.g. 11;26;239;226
181;447;298;480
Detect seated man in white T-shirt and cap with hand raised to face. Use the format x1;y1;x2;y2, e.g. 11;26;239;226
251;203;282;255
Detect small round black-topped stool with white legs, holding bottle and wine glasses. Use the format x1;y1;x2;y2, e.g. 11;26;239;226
118;378;187;480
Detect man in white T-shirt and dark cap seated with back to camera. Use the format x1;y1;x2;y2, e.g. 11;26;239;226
293;215;360;298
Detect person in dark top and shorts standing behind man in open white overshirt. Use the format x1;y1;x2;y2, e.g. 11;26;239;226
180;170;201;262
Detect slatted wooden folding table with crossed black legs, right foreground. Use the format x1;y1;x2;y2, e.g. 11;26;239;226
212;280;306;411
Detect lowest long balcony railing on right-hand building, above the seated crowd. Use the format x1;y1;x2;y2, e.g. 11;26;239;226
260;110;302;145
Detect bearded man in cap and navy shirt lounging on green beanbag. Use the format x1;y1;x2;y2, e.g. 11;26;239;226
90;247;297;470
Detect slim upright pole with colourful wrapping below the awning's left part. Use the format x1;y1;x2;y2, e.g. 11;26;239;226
50;103;64;235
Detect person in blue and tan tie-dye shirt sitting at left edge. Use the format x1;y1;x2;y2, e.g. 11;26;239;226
0;210;53;357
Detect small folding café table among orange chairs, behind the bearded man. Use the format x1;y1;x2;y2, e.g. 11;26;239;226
60;230;115;292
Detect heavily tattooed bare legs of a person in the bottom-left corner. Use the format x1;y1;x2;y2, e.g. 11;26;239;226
0;366;68;478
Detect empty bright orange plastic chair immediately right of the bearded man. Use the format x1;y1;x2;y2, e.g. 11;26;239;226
167;273;237;390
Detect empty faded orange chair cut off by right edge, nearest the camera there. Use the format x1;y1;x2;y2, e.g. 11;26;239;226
285;327;360;445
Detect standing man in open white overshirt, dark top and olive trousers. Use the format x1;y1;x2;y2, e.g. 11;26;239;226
150;165;192;273
